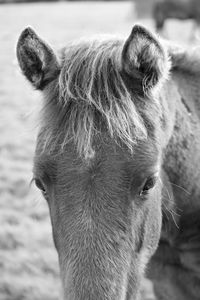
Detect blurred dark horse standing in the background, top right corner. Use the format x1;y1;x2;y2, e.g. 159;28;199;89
153;0;200;37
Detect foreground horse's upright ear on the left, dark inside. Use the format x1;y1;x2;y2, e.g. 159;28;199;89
17;28;60;90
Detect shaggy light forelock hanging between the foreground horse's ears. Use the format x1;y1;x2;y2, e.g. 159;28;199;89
42;39;155;158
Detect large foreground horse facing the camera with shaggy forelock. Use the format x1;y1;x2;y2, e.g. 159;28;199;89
17;25;200;300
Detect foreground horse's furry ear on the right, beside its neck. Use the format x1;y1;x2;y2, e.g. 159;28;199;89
122;25;170;92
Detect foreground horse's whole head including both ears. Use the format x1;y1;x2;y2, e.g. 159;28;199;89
17;26;168;300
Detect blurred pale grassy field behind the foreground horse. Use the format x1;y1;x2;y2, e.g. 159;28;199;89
0;0;200;300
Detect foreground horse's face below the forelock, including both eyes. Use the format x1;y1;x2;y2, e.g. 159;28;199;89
34;137;161;300
